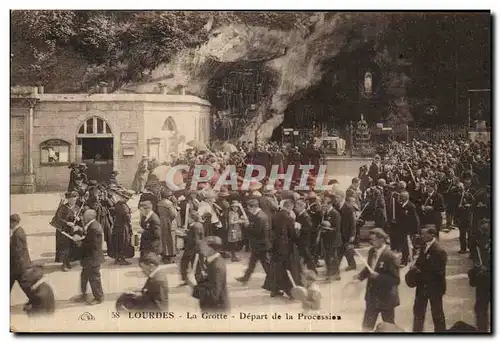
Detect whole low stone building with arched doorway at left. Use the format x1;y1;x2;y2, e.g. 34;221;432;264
10;87;211;193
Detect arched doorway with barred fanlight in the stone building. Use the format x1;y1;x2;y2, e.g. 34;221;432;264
76;116;113;182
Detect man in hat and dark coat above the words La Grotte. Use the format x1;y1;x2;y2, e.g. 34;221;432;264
193;236;230;312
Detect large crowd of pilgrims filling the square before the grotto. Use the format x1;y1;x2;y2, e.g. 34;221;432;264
9;136;491;331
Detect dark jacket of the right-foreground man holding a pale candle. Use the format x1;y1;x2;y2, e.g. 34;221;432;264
358;246;400;309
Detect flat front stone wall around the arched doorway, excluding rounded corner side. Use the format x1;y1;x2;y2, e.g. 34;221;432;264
33;96;145;191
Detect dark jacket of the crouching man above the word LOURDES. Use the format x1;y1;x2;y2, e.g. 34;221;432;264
140;266;168;311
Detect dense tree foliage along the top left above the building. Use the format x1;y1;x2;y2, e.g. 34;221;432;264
11;11;313;91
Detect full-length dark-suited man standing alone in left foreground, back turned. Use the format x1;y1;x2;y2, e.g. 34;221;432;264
73;209;104;305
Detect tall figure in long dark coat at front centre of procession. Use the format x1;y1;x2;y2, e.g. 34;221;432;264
264;200;301;299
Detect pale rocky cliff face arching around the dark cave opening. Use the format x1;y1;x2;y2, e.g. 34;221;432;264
120;13;387;140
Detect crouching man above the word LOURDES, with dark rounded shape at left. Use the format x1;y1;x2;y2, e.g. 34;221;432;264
116;252;168;312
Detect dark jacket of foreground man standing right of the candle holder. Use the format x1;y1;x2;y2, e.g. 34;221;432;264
410;241;448;296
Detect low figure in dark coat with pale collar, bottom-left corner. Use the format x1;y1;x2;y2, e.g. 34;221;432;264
25;265;56;316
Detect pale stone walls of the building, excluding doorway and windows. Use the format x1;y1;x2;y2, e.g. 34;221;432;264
11;94;210;193
